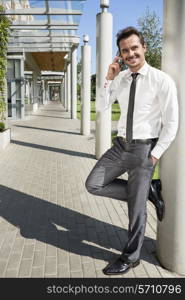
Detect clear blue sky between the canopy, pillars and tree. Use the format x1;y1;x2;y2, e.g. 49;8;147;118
77;0;163;74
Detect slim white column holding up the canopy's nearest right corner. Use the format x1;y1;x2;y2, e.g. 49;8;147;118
71;48;77;119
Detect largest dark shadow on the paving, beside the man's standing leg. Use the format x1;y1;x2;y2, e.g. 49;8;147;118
0;185;157;264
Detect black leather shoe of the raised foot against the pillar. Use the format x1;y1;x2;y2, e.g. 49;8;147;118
148;179;165;221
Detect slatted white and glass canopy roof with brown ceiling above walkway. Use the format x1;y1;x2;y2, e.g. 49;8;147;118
1;0;85;71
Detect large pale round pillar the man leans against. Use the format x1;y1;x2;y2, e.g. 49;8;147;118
157;0;185;275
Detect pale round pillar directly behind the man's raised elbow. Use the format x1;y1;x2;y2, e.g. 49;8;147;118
95;0;113;159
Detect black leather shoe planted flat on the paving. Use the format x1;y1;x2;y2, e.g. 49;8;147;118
102;257;140;275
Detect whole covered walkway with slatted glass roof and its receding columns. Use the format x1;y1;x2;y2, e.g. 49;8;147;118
0;0;85;119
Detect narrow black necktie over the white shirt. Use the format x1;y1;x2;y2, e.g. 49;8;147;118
126;73;139;142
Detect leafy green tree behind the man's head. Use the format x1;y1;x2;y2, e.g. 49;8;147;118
137;8;162;69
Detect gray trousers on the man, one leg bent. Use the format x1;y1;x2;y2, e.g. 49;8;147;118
86;137;156;261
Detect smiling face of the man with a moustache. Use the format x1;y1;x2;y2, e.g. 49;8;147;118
119;34;146;72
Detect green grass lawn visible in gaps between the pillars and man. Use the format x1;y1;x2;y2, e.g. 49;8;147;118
77;100;160;179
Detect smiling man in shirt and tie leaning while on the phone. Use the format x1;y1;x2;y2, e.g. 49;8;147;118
86;27;178;275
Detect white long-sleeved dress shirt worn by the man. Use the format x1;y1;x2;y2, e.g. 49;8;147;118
96;62;178;159
